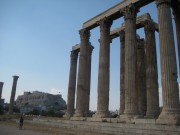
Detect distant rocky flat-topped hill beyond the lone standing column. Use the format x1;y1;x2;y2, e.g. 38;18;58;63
16;91;66;113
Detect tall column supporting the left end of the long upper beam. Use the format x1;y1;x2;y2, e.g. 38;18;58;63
74;29;90;117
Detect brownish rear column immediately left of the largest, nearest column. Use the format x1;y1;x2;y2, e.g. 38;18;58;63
144;21;160;118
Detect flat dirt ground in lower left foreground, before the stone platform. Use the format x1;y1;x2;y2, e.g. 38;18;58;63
0;121;107;135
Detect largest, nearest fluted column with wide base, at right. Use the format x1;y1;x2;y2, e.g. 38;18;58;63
156;0;180;125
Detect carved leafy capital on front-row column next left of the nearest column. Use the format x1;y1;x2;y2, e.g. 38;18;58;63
121;4;138;20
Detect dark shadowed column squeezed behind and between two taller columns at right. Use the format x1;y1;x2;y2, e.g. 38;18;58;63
136;38;146;116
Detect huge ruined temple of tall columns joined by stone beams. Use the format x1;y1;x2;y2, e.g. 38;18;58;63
66;0;180;125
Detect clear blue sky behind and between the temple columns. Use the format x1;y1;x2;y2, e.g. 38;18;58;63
0;0;180;110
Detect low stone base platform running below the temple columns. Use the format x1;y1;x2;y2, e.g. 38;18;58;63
29;118;180;135
